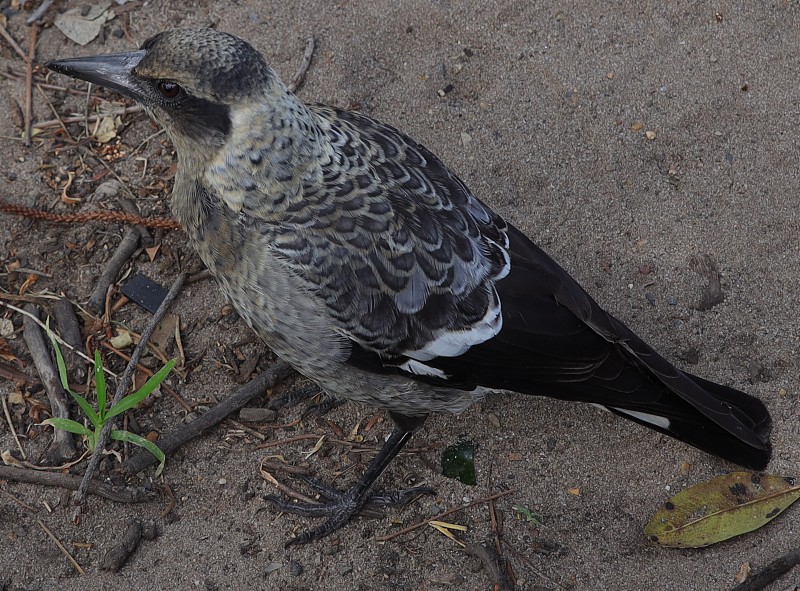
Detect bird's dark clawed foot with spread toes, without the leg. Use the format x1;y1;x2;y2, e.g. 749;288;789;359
264;477;436;547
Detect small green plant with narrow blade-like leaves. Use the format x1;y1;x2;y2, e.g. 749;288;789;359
44;326;176;476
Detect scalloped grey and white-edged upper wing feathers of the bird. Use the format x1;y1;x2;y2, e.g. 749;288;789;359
248;107;510;374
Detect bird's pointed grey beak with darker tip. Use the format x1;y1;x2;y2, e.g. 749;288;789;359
46;49;147;100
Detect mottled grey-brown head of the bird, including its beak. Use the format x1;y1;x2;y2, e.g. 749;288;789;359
47;29;286;151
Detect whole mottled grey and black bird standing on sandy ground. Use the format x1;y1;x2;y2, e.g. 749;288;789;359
47;28;771;544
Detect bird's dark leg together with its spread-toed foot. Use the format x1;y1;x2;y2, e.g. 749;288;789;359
264;413;433;546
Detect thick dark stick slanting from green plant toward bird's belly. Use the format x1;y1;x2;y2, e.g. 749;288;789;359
122;358;293;474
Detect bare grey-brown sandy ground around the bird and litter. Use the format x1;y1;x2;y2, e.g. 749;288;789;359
0;0;800;591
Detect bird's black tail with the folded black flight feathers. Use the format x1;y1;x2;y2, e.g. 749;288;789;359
426;227;772;470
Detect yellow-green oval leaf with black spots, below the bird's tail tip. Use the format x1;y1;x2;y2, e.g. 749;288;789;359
644;472;800;548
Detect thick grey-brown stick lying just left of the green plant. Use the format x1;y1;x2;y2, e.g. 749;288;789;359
22;304;77;466
